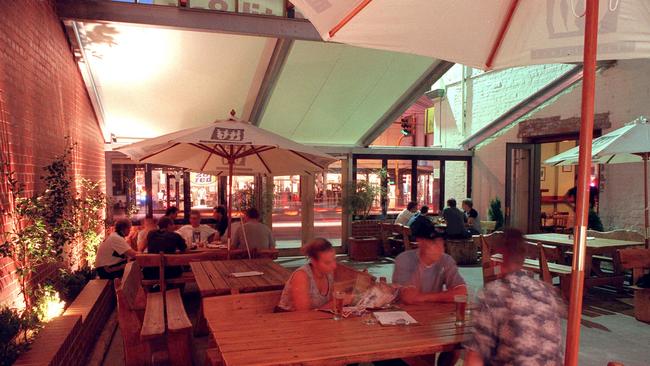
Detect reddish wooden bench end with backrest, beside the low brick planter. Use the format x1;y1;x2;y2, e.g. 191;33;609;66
115;262;159;366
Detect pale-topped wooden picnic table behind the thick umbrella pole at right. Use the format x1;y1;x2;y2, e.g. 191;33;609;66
524;233;645;288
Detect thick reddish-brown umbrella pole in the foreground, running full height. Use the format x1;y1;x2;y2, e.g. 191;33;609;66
564;0;598;366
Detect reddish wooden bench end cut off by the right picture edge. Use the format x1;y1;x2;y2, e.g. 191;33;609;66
617;248;650;322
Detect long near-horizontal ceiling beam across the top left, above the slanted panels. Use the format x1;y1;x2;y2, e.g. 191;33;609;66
56;0;322;41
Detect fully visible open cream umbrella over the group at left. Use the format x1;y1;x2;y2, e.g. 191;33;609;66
117;111;336;249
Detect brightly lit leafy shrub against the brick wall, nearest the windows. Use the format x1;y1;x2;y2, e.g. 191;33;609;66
73;179;107;265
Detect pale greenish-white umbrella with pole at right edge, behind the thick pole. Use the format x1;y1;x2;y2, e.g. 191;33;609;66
544;117;650;247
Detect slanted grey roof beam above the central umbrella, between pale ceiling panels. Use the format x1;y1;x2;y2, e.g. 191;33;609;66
248;38;293;126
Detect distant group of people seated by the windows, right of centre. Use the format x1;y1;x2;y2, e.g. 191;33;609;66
395;198;481;239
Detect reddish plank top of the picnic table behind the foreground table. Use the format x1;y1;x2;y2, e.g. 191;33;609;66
190;258;291;297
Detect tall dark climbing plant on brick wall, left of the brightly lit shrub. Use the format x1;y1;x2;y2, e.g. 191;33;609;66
41;137;76;256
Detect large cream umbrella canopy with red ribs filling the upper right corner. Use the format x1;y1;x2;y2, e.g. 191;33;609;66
292;0;650;69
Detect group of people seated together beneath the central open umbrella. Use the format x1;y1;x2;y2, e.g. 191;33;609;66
95;206;275;279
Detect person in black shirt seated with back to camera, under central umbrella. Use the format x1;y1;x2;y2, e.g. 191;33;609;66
142;217;187;279
